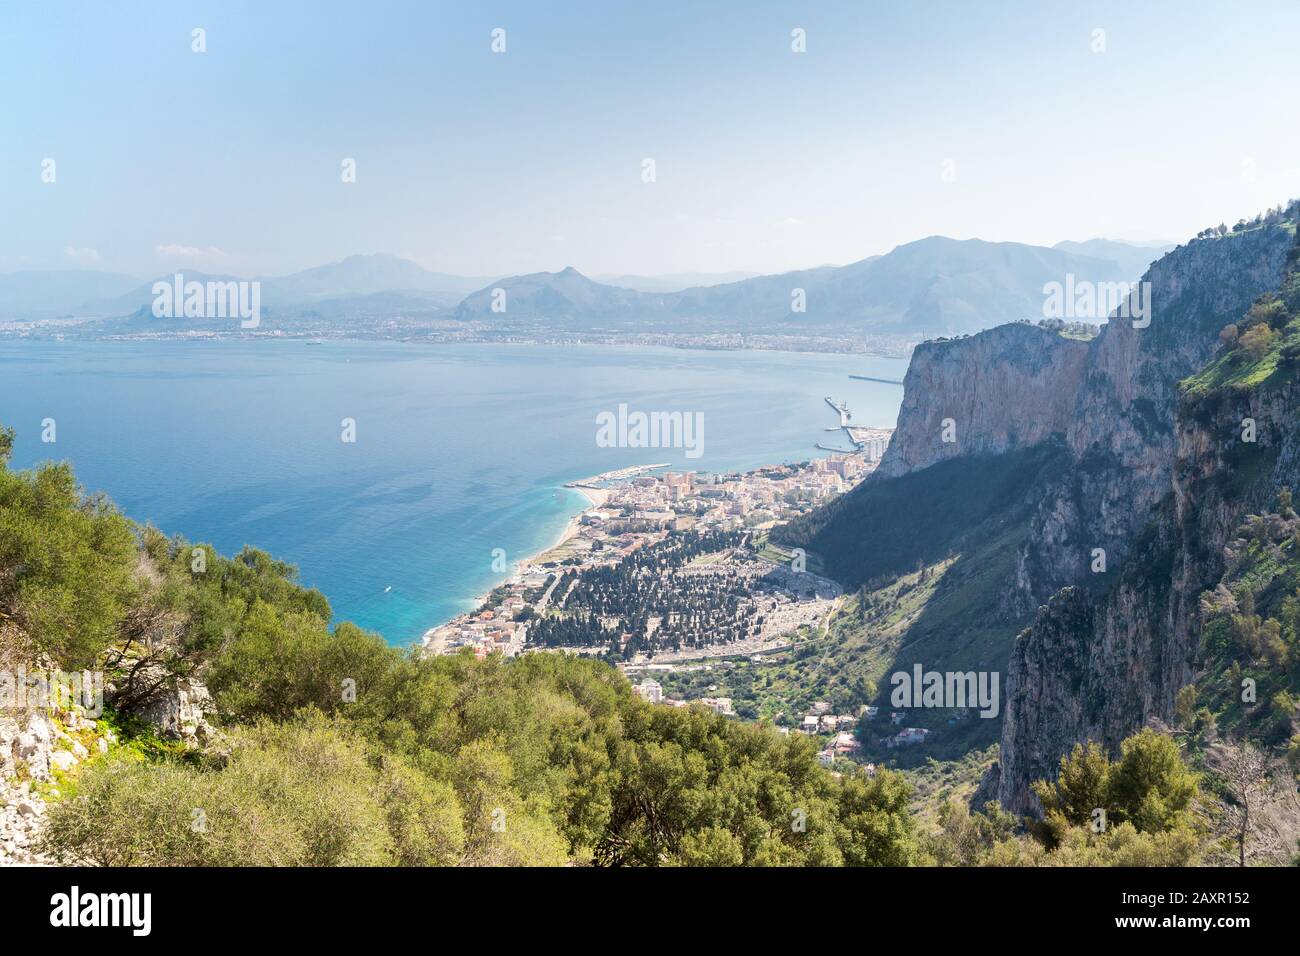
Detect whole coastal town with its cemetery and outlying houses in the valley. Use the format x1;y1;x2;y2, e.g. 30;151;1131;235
423;421;899;763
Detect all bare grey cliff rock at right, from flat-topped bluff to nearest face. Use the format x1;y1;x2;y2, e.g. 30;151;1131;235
871;218;1300;812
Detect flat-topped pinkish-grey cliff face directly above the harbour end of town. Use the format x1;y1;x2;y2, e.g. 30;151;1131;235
876;323;1088;477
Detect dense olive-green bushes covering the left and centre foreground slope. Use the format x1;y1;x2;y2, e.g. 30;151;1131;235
0;433;915;866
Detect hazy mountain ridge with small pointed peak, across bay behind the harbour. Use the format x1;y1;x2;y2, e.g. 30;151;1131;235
456;235;1139;338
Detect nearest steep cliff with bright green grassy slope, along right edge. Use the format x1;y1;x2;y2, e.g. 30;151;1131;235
1000;208;1300;806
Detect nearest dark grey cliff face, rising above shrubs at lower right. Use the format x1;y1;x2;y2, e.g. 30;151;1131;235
998;371;1300;813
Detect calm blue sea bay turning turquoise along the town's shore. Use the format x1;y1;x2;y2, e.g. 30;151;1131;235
0;341;906;644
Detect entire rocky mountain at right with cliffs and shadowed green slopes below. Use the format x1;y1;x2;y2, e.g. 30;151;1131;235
774;203;1300;813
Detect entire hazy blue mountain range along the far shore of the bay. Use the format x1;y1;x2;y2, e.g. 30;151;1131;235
0;235;1166;338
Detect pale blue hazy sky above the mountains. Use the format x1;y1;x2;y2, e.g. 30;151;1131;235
0;0;1300;277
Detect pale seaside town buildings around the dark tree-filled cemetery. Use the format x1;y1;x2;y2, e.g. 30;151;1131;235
423;429;889;686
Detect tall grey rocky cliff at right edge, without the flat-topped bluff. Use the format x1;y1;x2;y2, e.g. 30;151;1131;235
997;224;1300;812
